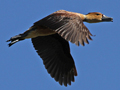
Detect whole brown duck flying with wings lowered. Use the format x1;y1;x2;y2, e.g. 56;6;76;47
7;10;113;86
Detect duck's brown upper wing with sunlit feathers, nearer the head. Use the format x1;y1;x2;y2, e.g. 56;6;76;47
34;10;92;46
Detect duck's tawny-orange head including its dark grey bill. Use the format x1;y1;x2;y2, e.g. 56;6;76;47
84;12;113;23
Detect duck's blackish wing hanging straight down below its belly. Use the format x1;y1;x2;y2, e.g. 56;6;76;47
32;34;77;86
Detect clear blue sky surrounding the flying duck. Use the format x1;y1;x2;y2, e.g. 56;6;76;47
0;0;120;90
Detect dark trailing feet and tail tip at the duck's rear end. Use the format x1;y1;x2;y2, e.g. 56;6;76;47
6;34;24;47
